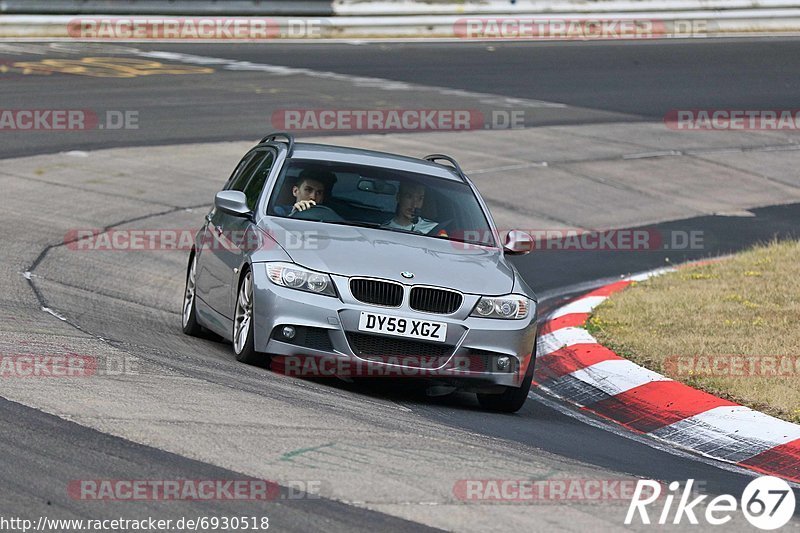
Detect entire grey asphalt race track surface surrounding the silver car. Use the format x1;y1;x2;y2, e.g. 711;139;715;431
0;38;800;531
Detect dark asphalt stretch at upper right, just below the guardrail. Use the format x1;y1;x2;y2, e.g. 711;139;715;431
155;39;800;115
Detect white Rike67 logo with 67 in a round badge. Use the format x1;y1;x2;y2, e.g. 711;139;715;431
625;476;795;530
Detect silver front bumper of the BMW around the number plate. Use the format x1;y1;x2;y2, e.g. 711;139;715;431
253;263;536;387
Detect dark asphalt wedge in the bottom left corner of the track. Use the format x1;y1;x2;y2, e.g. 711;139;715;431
0;398;437;532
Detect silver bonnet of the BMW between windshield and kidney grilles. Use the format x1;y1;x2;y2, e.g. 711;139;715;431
264;218;514;295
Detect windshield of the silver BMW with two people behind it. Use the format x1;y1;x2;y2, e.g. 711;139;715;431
267;160;496;247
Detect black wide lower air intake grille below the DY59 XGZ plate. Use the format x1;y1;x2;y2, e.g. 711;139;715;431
347;333;453;368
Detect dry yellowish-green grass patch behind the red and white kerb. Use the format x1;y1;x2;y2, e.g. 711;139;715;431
587;241;800;422
